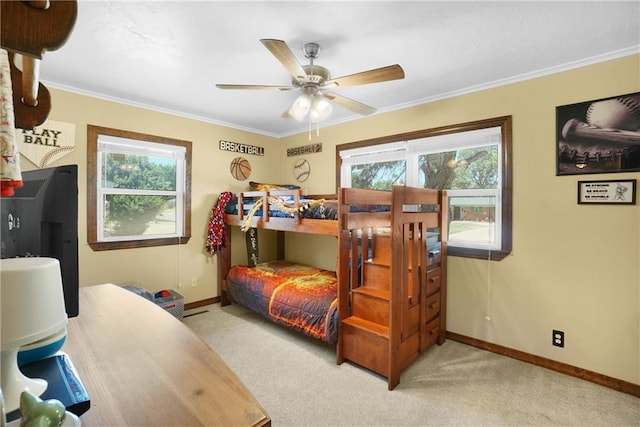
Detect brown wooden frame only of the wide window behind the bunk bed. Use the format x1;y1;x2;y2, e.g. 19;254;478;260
335;116;513;261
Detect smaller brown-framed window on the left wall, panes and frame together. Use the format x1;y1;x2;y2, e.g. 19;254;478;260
87;125;191;250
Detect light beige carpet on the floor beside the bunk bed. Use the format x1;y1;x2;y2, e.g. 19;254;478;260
184;304;640;427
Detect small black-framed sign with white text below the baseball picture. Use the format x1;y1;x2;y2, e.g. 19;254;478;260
578;179;636;205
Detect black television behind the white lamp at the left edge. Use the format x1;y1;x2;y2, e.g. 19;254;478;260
0;165;80;318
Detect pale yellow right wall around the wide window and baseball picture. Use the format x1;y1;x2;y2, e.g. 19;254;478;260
282;56;640;384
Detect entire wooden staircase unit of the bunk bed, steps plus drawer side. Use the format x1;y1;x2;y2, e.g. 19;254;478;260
338;186;447;390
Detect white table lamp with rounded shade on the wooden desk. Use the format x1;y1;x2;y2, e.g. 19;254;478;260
0;257;67;413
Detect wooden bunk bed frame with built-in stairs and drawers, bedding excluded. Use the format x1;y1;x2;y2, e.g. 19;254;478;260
218;185;447;390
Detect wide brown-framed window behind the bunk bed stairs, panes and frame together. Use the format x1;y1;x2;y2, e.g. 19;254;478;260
336;117;511;260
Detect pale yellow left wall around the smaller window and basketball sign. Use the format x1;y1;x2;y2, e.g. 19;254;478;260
28;89;280;304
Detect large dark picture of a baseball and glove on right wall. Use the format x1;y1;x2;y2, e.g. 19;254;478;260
556;92;640;175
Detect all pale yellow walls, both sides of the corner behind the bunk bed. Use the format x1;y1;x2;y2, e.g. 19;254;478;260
30;55;640;384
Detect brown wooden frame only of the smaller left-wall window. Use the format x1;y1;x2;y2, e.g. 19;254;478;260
87;125;192;251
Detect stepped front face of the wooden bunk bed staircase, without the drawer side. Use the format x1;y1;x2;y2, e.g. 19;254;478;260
338;188;391;377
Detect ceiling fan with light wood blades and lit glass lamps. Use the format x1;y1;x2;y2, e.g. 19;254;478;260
216;39;404;123
